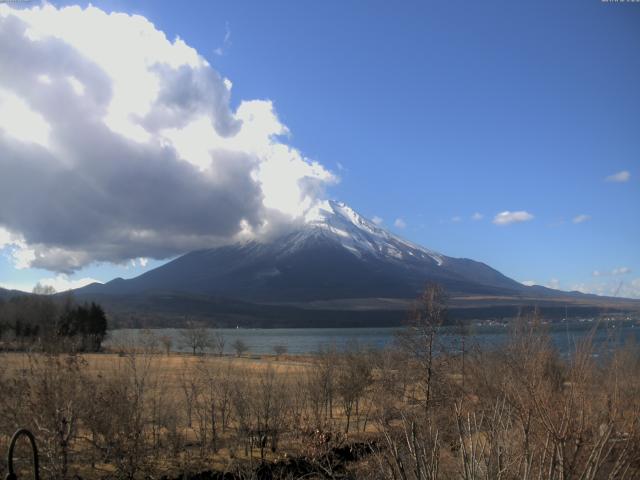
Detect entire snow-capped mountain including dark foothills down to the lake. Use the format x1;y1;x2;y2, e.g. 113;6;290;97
75;201;636;326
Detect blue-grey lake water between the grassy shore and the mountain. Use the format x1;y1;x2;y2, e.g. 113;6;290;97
105;322;640;355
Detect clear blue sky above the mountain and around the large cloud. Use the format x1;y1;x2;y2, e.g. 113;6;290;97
0;0;640;297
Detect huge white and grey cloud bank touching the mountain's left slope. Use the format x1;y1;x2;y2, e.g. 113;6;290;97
0;4;336;273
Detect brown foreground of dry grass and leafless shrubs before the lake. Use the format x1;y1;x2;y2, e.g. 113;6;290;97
0;285;640;480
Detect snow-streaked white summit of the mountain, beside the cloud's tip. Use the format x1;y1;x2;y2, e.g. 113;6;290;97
292;200;444;265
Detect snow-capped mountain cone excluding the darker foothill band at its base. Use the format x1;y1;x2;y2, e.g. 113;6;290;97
80;202;527;302
